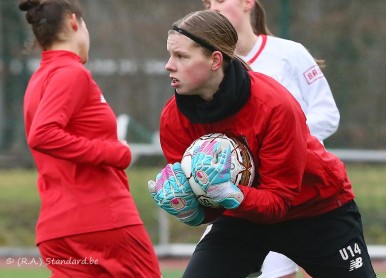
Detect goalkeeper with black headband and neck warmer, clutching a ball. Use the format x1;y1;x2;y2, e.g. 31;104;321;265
149;10;375;278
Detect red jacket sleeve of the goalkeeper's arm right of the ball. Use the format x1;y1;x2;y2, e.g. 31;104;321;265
225;97;308;223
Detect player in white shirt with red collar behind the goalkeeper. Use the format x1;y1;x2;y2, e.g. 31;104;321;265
203;0;340;278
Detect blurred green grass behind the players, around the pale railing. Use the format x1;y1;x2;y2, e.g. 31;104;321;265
0;164;386;278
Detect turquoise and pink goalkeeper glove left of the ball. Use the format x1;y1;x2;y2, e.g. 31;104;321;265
148;162;205;226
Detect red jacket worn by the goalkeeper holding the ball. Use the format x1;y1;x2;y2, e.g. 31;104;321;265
160;71;354;223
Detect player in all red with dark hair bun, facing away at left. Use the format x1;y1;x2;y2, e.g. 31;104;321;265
19;0;161;278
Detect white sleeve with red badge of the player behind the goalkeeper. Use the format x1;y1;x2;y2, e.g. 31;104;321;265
291;44;340;141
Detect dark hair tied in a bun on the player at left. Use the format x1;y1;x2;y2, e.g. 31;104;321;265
19;0;82;49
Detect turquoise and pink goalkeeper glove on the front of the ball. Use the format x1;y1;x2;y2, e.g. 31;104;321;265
192;141;244;209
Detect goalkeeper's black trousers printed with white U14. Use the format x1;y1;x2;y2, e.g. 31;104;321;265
183;201;376;278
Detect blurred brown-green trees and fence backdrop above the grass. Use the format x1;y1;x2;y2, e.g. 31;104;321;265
0;0;386;167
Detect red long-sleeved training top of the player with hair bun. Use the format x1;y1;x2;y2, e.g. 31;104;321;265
24;51;142;244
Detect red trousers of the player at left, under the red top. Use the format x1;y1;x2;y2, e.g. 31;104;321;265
38;225;161;278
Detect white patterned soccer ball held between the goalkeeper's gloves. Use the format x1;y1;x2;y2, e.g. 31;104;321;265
181;133;255;208
